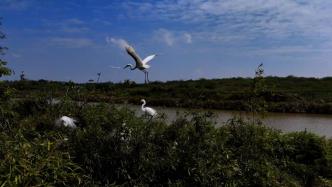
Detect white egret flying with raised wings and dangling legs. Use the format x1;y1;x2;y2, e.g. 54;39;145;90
123;45;157;83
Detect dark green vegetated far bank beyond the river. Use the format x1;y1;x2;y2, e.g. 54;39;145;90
4;76;332;114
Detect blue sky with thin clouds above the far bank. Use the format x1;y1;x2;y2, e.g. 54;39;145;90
0;0;332;82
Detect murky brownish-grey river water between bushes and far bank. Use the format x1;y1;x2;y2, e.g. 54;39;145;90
122;105;332;138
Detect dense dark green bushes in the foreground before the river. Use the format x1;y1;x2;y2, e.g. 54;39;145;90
0;98;332;186
